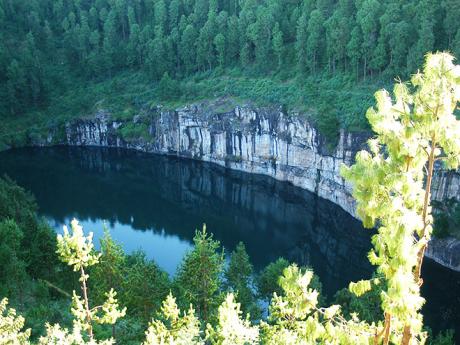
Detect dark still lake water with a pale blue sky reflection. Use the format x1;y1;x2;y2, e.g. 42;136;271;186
0;147;460;334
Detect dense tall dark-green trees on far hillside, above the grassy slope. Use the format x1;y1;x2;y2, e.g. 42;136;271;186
0;0;460;114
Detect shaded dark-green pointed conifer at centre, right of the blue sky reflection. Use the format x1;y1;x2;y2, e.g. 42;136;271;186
175;226;224;322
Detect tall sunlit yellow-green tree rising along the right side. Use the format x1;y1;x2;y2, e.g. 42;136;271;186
342;53;460;345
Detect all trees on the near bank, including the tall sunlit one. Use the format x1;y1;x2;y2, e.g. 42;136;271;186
0;53;460;345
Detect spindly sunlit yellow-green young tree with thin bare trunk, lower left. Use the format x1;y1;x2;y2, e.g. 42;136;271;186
47;219;126;344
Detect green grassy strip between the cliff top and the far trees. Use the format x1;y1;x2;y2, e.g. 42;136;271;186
0;69;382;145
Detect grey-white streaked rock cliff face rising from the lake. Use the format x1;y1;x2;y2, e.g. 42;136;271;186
60;104;460;270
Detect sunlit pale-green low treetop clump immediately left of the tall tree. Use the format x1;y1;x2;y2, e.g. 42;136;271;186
262;265;376;345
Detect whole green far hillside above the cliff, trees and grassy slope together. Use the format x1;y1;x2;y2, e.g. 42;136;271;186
0;0;460;146
